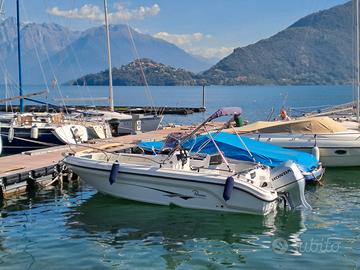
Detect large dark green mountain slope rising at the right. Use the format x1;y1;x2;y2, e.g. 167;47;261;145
203;2;353;85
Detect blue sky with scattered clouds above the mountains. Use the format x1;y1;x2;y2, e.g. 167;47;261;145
0;0;347;59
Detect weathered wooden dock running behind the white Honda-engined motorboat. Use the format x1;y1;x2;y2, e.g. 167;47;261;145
0;123;219;199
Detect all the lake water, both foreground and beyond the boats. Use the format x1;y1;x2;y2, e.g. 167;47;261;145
0;86;360;269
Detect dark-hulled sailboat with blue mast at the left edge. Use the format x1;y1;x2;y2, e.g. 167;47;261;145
0;0;107;154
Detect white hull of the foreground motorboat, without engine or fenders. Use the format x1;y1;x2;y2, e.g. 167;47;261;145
65;158;278;215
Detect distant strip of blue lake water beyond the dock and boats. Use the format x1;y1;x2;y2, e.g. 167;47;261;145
9;86;354;124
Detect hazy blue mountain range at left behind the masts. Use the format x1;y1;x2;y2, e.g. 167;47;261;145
0;18;210;84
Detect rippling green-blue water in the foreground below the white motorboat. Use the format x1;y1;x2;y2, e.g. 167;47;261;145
0;167;360;269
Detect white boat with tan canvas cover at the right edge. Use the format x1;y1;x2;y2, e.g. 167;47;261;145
226;117;360;167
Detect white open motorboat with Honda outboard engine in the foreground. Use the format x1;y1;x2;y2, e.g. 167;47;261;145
64;108;311;215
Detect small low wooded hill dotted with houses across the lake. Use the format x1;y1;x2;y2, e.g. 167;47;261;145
70;59;204;86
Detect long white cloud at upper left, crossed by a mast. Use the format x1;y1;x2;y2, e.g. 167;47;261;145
47;3;160;23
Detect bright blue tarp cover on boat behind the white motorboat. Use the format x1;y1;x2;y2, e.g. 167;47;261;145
139;132;319;172
